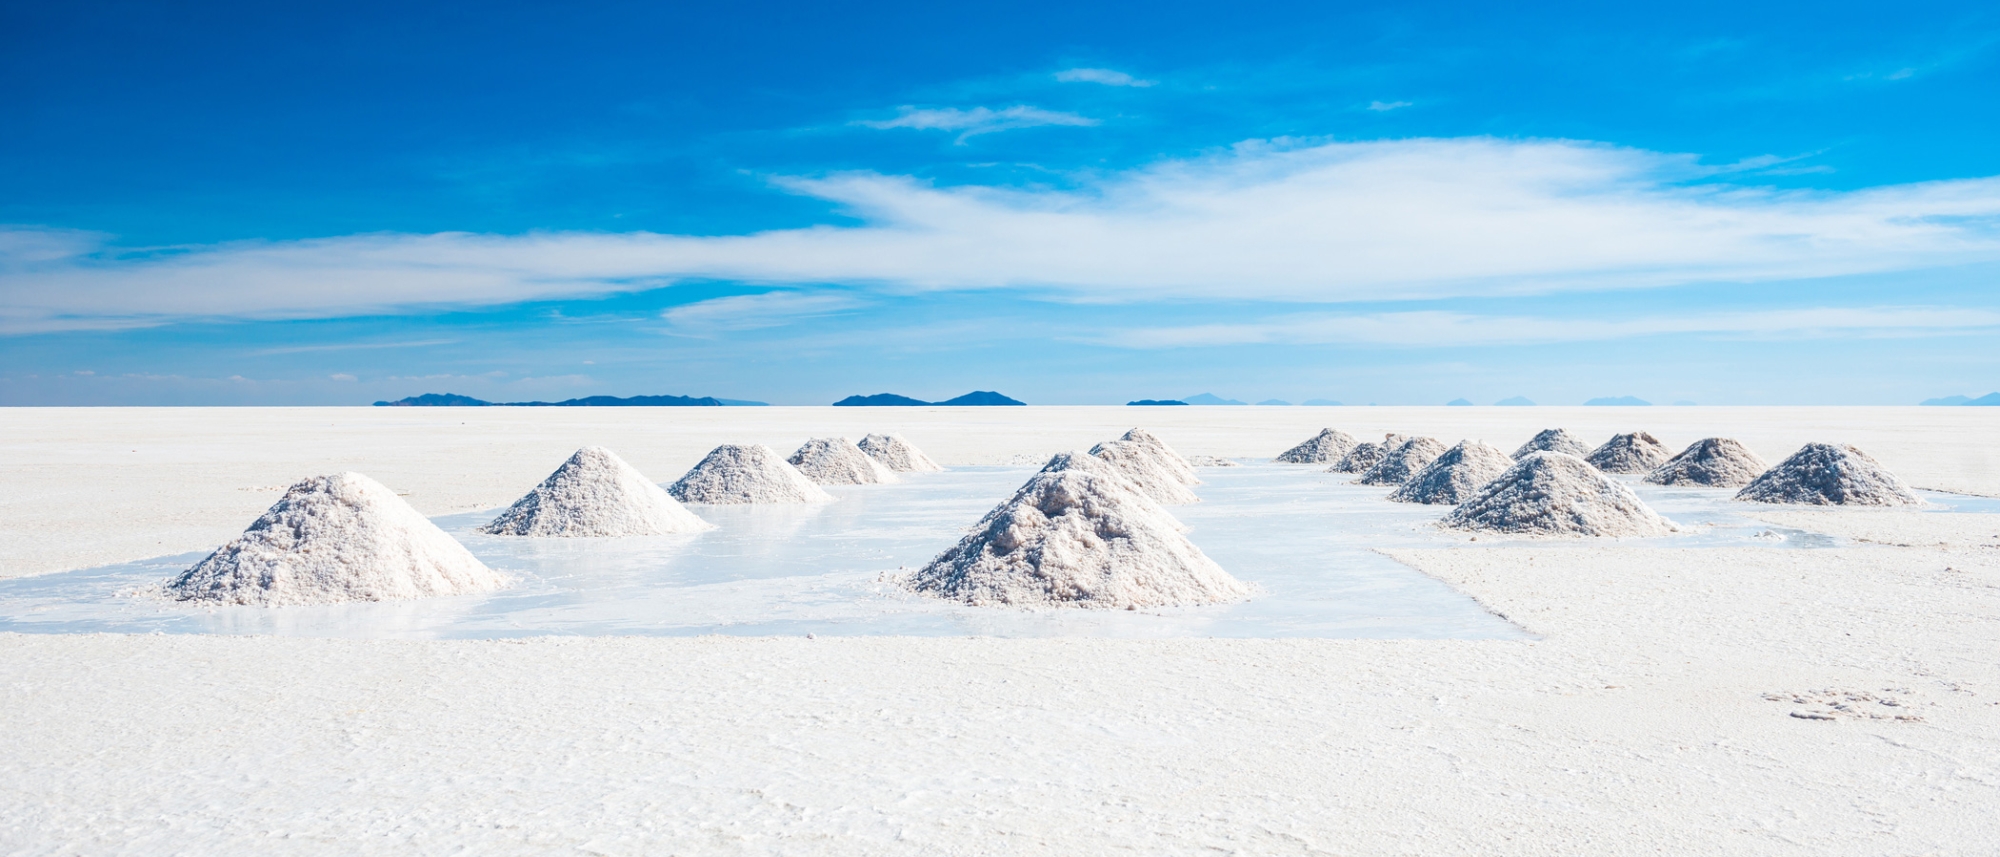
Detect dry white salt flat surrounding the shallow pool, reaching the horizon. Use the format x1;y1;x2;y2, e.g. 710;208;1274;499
0;408;2000;855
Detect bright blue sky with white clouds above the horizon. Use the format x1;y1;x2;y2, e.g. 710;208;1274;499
0;2;2000;404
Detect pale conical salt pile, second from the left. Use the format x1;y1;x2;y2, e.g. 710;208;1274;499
480;447;716;537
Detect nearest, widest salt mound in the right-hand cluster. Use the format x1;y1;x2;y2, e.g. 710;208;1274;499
1438;453;1674;537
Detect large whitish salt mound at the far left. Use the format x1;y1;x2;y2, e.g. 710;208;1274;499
162;473;506;607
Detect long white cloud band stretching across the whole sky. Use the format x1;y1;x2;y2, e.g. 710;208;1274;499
0;138;2000;330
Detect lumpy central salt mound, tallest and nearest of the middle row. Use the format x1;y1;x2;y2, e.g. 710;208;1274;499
902;463;1250;609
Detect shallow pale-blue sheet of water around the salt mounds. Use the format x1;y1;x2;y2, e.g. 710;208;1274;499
0;463;2000;639
